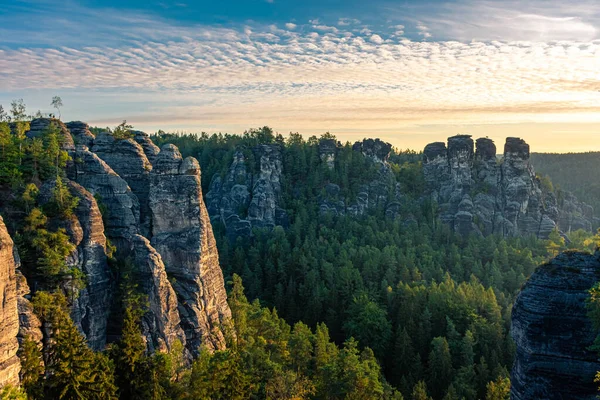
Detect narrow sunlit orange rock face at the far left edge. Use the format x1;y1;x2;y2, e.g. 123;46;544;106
0;217;21;387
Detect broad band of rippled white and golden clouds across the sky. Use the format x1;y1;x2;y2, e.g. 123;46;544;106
0;0;600;141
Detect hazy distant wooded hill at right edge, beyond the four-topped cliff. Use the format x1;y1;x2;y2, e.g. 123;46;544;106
530;152;600;216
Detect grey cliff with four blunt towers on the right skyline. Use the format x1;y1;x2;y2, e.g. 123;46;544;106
423;135;592;238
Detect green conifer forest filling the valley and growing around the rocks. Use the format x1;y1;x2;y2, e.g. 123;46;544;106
0;102;598;400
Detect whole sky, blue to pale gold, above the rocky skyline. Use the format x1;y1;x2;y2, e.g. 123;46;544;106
0;0;600;152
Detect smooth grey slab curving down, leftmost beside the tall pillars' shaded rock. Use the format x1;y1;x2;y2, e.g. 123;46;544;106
67;145;140;251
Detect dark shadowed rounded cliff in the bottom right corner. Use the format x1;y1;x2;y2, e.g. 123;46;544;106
511;253;600;400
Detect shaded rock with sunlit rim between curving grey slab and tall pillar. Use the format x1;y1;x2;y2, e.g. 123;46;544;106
92;132;152;237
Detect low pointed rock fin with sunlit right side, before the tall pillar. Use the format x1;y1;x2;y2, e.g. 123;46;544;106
133;235;186;352
